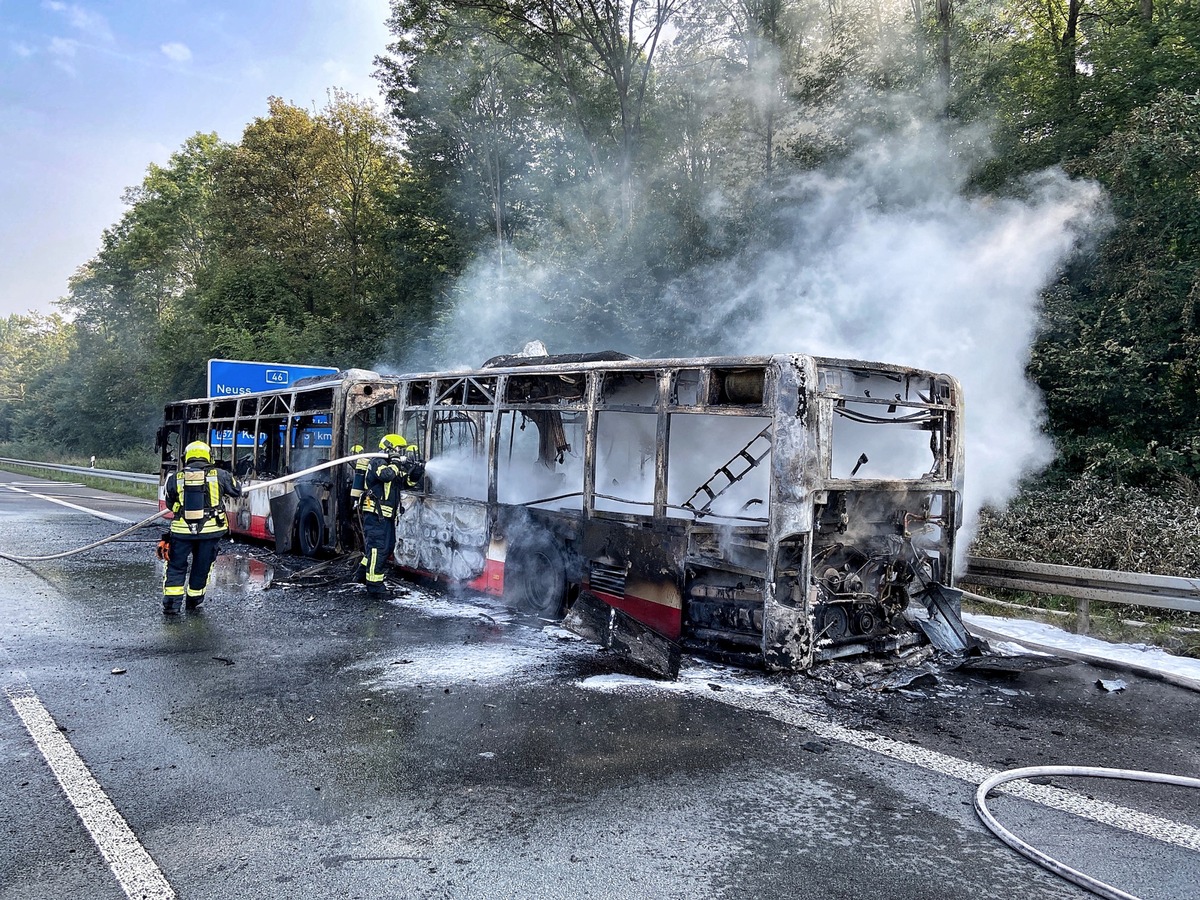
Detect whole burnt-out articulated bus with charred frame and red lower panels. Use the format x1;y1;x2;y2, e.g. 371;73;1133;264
160;353;970;674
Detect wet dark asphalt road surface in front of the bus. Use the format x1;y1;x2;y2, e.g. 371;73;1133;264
0;473;1200;900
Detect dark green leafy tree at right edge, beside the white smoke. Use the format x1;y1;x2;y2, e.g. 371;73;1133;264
1034;90;1200;487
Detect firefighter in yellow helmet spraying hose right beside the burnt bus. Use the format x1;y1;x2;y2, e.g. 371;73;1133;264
359;434;425;596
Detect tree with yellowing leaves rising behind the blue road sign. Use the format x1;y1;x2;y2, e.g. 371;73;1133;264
200;91;403;362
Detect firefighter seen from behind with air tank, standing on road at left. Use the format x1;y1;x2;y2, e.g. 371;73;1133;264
162;440;241;616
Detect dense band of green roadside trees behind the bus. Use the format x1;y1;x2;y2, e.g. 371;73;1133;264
0;0;1200;494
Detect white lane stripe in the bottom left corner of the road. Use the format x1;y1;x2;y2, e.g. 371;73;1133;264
4;686;175;900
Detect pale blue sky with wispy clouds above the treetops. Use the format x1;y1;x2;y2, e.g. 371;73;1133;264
0;0;389;316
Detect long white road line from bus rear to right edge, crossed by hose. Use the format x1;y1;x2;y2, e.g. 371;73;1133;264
581;672;1200;852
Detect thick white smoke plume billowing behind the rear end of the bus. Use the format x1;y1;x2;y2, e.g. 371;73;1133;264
674;127;1106;532
